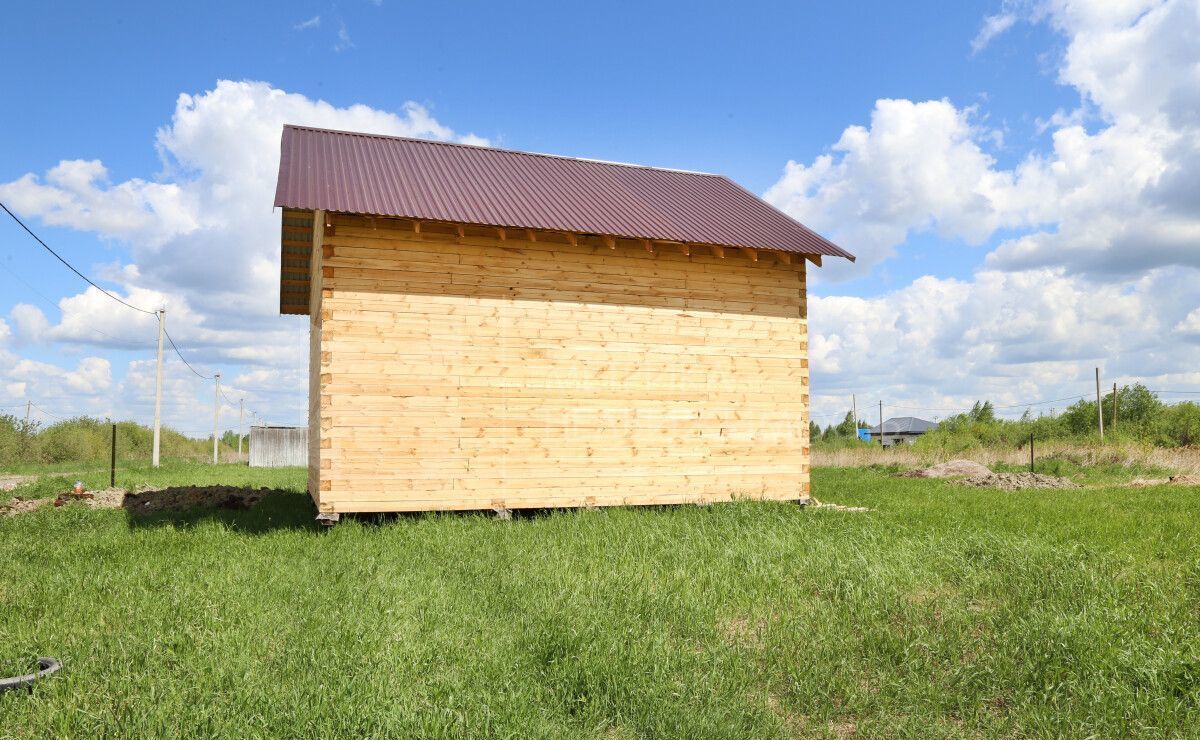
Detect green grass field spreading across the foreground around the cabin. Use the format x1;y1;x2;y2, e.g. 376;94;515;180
0;467;1200;738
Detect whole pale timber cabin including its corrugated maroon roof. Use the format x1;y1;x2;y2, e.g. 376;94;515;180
275;126;853;519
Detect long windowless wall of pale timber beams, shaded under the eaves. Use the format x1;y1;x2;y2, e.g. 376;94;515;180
310;213;809;512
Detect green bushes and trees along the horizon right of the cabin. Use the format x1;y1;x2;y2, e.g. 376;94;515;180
809;383;1200;451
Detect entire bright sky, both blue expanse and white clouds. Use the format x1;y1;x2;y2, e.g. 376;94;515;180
0;0;1200;433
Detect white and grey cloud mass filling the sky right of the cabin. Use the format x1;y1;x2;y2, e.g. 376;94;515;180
787;0;1200;416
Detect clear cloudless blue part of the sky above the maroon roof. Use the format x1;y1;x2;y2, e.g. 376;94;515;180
0;1;1078;184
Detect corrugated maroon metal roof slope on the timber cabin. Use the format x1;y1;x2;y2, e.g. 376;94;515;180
275;126;854;260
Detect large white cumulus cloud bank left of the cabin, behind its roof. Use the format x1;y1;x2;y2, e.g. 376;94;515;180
0;80;487;426
